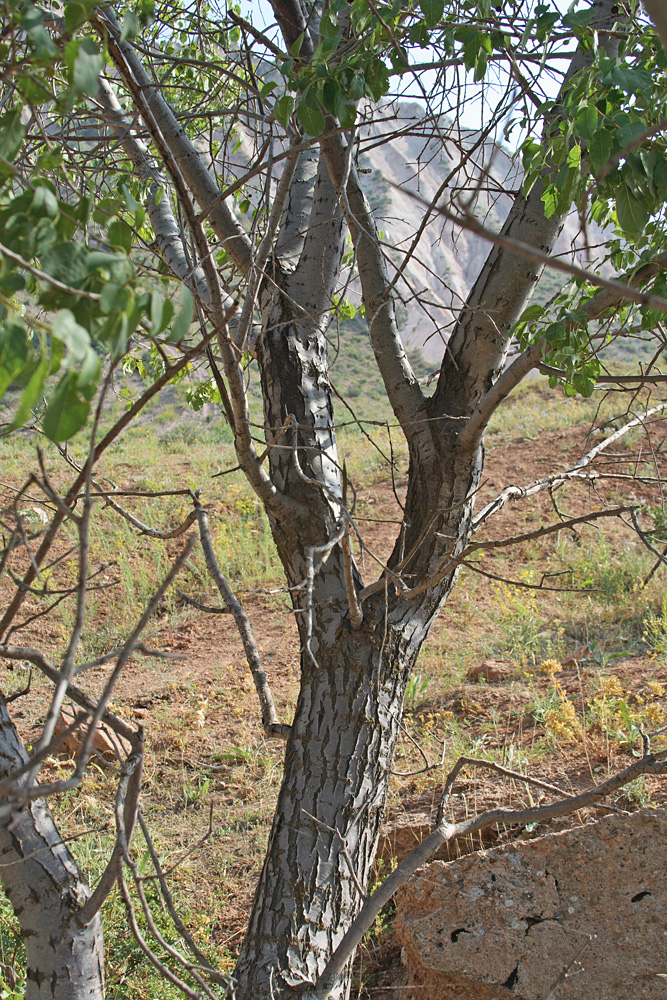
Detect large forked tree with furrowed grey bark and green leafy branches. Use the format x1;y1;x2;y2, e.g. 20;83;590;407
0;0;667;1000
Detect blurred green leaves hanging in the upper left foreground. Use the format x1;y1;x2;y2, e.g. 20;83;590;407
0;3;193;441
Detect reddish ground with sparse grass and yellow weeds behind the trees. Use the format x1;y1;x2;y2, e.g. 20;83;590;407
0;380;667;1000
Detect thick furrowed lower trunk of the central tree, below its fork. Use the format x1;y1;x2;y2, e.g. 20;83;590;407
236;616;414;1000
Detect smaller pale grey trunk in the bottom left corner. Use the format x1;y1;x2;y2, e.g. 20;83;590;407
0;699;104;1000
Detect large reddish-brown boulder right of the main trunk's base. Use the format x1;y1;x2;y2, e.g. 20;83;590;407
394;810;667;1000
